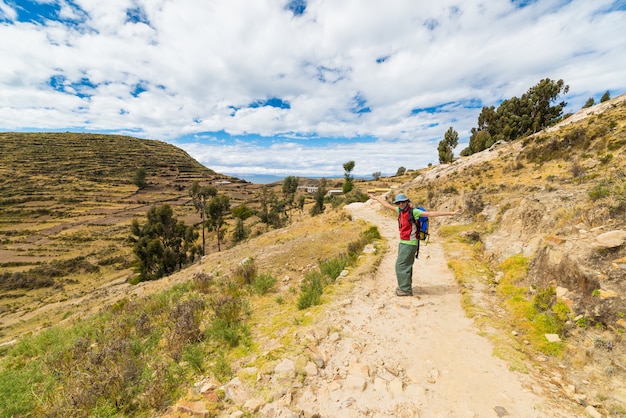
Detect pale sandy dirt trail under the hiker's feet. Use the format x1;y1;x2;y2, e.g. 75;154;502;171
297;201;575;418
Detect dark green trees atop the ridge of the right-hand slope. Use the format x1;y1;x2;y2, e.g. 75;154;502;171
438;78;576;163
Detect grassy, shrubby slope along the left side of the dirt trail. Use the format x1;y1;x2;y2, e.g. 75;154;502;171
0;202;377;416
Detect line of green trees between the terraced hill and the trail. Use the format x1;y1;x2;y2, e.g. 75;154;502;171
131;161;368;281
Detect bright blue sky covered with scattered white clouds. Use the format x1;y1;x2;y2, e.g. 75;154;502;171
0;0;626;179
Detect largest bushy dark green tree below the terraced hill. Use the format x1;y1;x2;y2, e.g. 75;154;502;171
131;205;198;281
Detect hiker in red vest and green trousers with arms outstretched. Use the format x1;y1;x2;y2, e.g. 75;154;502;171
368;193;461;296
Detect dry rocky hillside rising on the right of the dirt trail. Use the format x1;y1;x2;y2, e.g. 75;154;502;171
394;96;626;416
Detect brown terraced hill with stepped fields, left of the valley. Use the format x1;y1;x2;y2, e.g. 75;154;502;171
0;133;259;341
